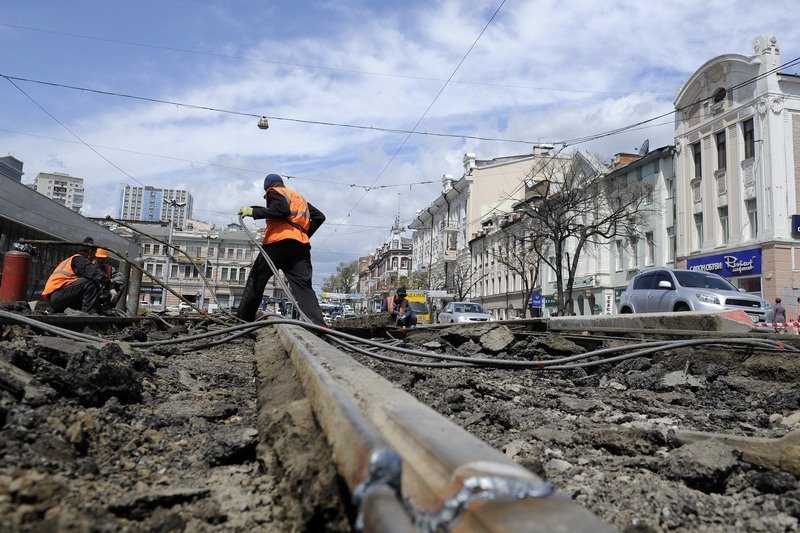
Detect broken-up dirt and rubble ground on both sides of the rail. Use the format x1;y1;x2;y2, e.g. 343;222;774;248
0;308;800;531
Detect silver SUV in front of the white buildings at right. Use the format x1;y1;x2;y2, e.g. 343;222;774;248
619;268;773;322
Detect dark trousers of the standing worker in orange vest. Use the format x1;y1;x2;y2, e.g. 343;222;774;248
237;239;325;326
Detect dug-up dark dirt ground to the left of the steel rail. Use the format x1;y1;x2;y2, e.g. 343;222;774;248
0;318;348;532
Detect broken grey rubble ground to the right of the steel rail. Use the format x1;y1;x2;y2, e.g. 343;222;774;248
358;324;800;531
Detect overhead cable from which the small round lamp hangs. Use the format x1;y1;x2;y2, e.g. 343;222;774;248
0;73;539;145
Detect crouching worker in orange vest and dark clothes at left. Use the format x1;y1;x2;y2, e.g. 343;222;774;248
42;237;110;314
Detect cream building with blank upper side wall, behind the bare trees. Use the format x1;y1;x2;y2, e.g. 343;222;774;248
409;147;548;291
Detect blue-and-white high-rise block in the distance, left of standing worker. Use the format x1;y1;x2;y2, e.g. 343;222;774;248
118;183;193;228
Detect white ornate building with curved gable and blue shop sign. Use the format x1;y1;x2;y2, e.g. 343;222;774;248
674;35;800;302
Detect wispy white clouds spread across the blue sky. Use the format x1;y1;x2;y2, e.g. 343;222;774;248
0;0;800;282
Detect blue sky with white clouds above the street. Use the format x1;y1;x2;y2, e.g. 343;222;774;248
0;0;800;286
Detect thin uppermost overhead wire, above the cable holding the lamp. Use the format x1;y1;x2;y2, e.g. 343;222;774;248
0;23;669;97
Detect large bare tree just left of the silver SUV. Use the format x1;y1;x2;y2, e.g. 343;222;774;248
522;152;655;313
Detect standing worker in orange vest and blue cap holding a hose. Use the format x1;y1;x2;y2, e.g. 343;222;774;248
236;174;325;326
